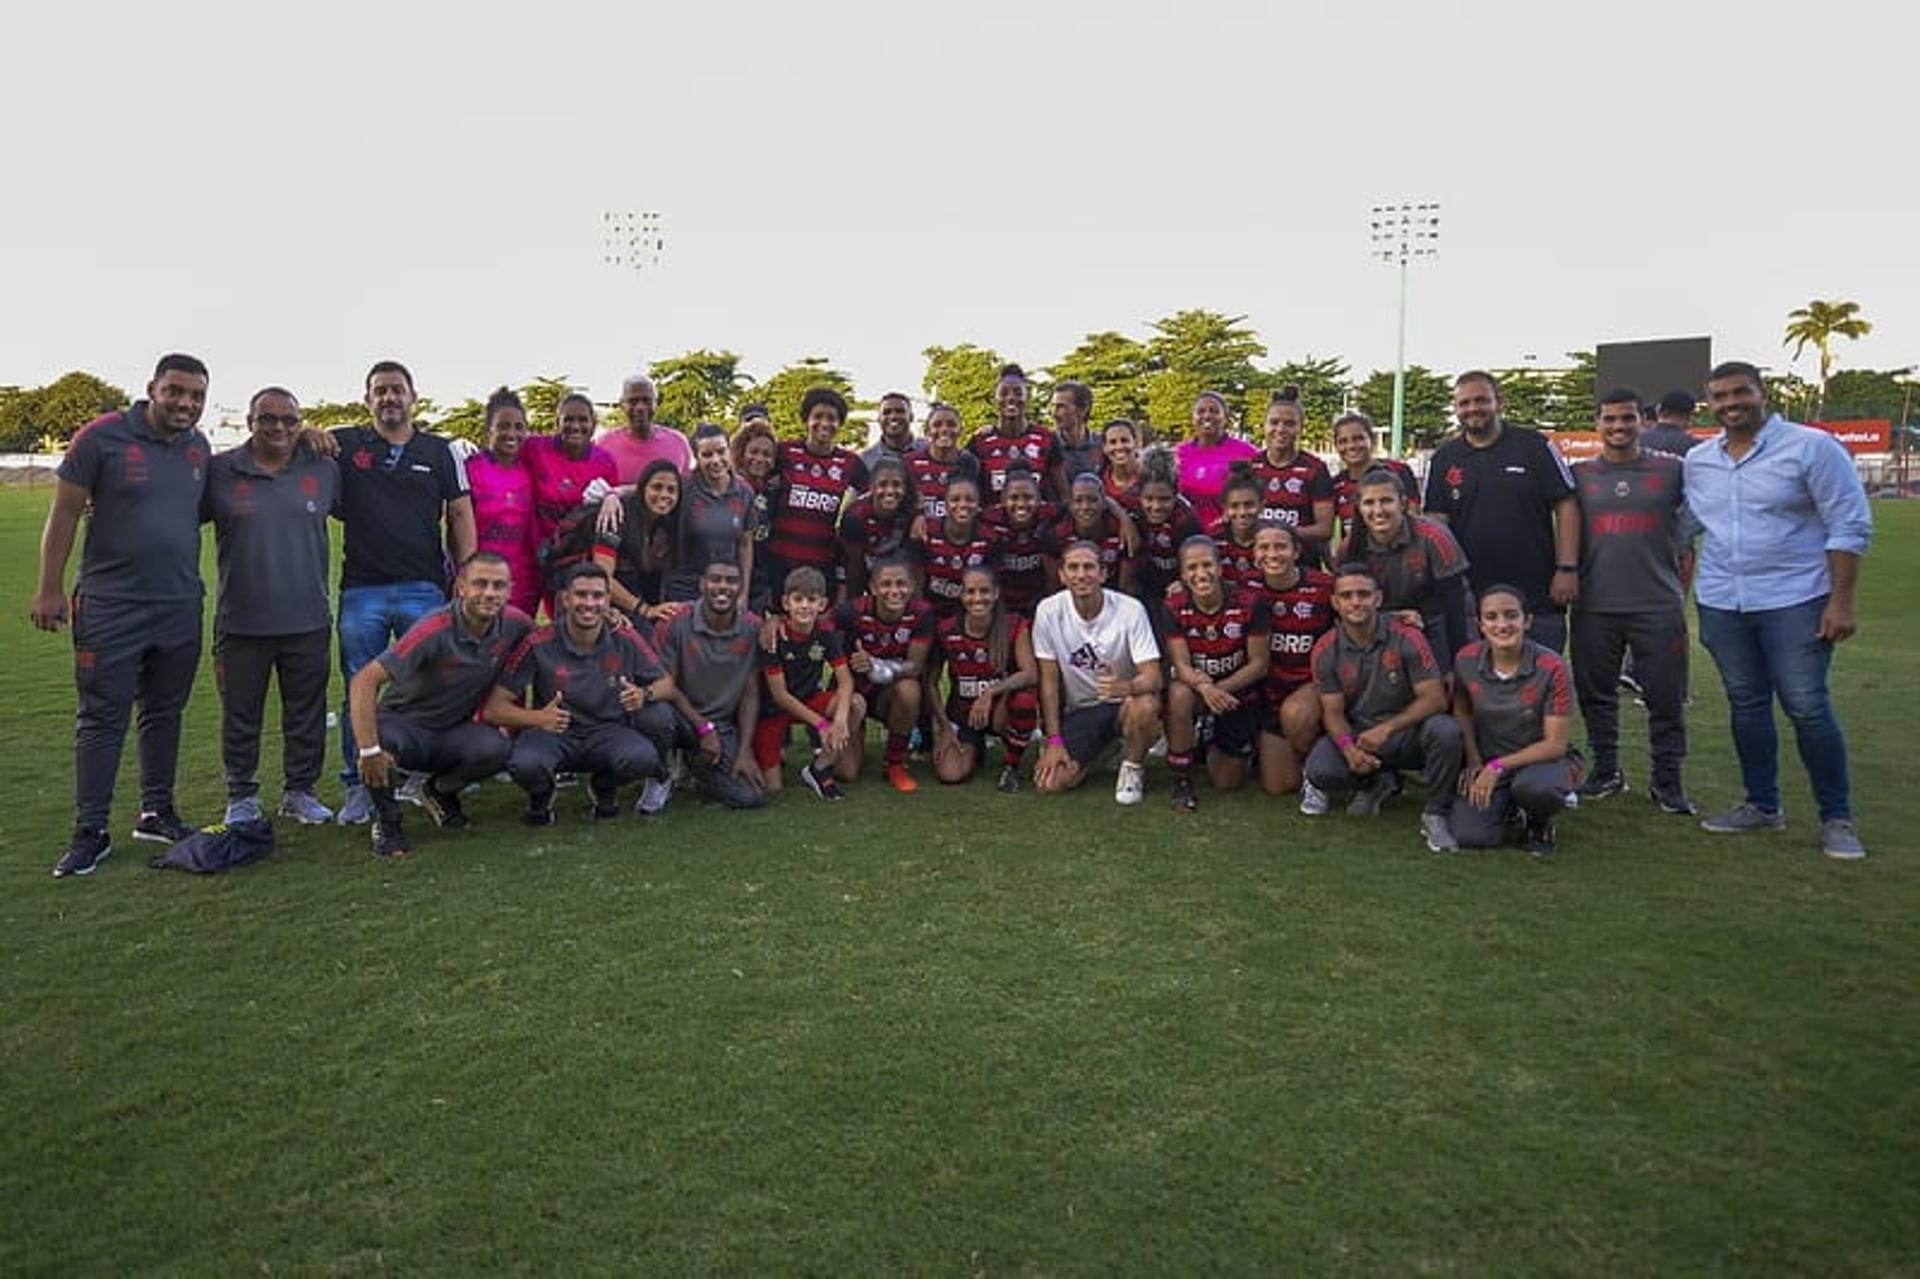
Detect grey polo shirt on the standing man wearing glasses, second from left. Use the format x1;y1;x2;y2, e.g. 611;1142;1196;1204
202;444;340;636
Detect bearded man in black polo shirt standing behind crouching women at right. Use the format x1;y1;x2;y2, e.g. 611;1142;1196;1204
1425;369;1580;653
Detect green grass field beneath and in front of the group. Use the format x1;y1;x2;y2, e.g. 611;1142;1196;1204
0;490;1920;1275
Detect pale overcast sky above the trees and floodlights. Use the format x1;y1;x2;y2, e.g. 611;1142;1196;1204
0;0;1920;405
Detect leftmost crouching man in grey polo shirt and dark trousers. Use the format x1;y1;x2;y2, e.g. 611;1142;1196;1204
348;551;534;857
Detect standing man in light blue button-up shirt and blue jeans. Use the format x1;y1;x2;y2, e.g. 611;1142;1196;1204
1686;361;1874;860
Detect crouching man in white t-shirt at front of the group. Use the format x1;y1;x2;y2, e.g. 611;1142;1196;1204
1033;542;1162;805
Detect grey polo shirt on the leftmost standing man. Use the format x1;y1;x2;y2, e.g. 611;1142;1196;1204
58;399;213;603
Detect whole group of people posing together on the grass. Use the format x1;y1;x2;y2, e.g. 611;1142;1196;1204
31;355;1870;876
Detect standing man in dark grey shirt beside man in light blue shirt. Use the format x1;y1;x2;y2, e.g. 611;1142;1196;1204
1572;388;1695;814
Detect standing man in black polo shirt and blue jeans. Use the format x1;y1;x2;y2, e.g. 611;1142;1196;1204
334;359;474;824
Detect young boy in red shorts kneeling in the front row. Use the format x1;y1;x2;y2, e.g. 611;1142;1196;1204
753;567;866;799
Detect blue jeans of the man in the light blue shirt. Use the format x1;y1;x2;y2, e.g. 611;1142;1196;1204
1699;595;1853;822
